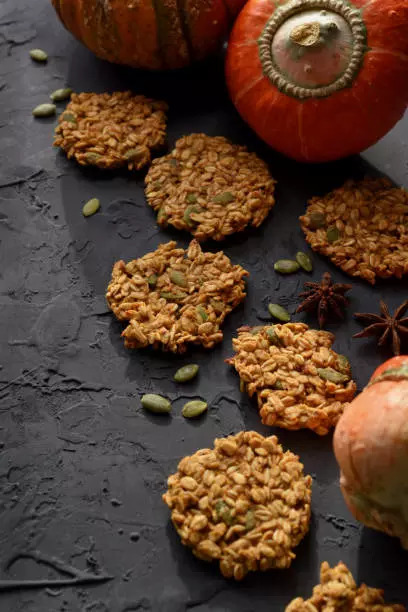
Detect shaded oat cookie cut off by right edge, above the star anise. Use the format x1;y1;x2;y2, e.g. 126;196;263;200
300;178;408;285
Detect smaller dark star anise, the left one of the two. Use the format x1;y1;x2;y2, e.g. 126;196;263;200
296;272;352;329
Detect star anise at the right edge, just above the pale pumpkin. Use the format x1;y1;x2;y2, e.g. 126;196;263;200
353;300;408;355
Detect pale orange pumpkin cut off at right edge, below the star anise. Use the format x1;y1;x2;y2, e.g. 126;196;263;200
334;355;408;549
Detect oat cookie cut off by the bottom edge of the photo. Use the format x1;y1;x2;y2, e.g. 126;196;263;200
285;561;406;612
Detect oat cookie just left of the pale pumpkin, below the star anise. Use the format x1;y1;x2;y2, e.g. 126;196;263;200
227;323;356;435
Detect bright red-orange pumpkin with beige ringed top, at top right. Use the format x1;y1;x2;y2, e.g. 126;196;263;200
226;0;408;162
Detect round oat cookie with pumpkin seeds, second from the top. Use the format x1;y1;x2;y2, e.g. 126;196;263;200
146;134;275;241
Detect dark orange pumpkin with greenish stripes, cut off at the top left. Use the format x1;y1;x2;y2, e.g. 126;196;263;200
51;0;245;70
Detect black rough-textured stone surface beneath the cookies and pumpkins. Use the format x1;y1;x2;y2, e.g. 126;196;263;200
0;0;408;612
